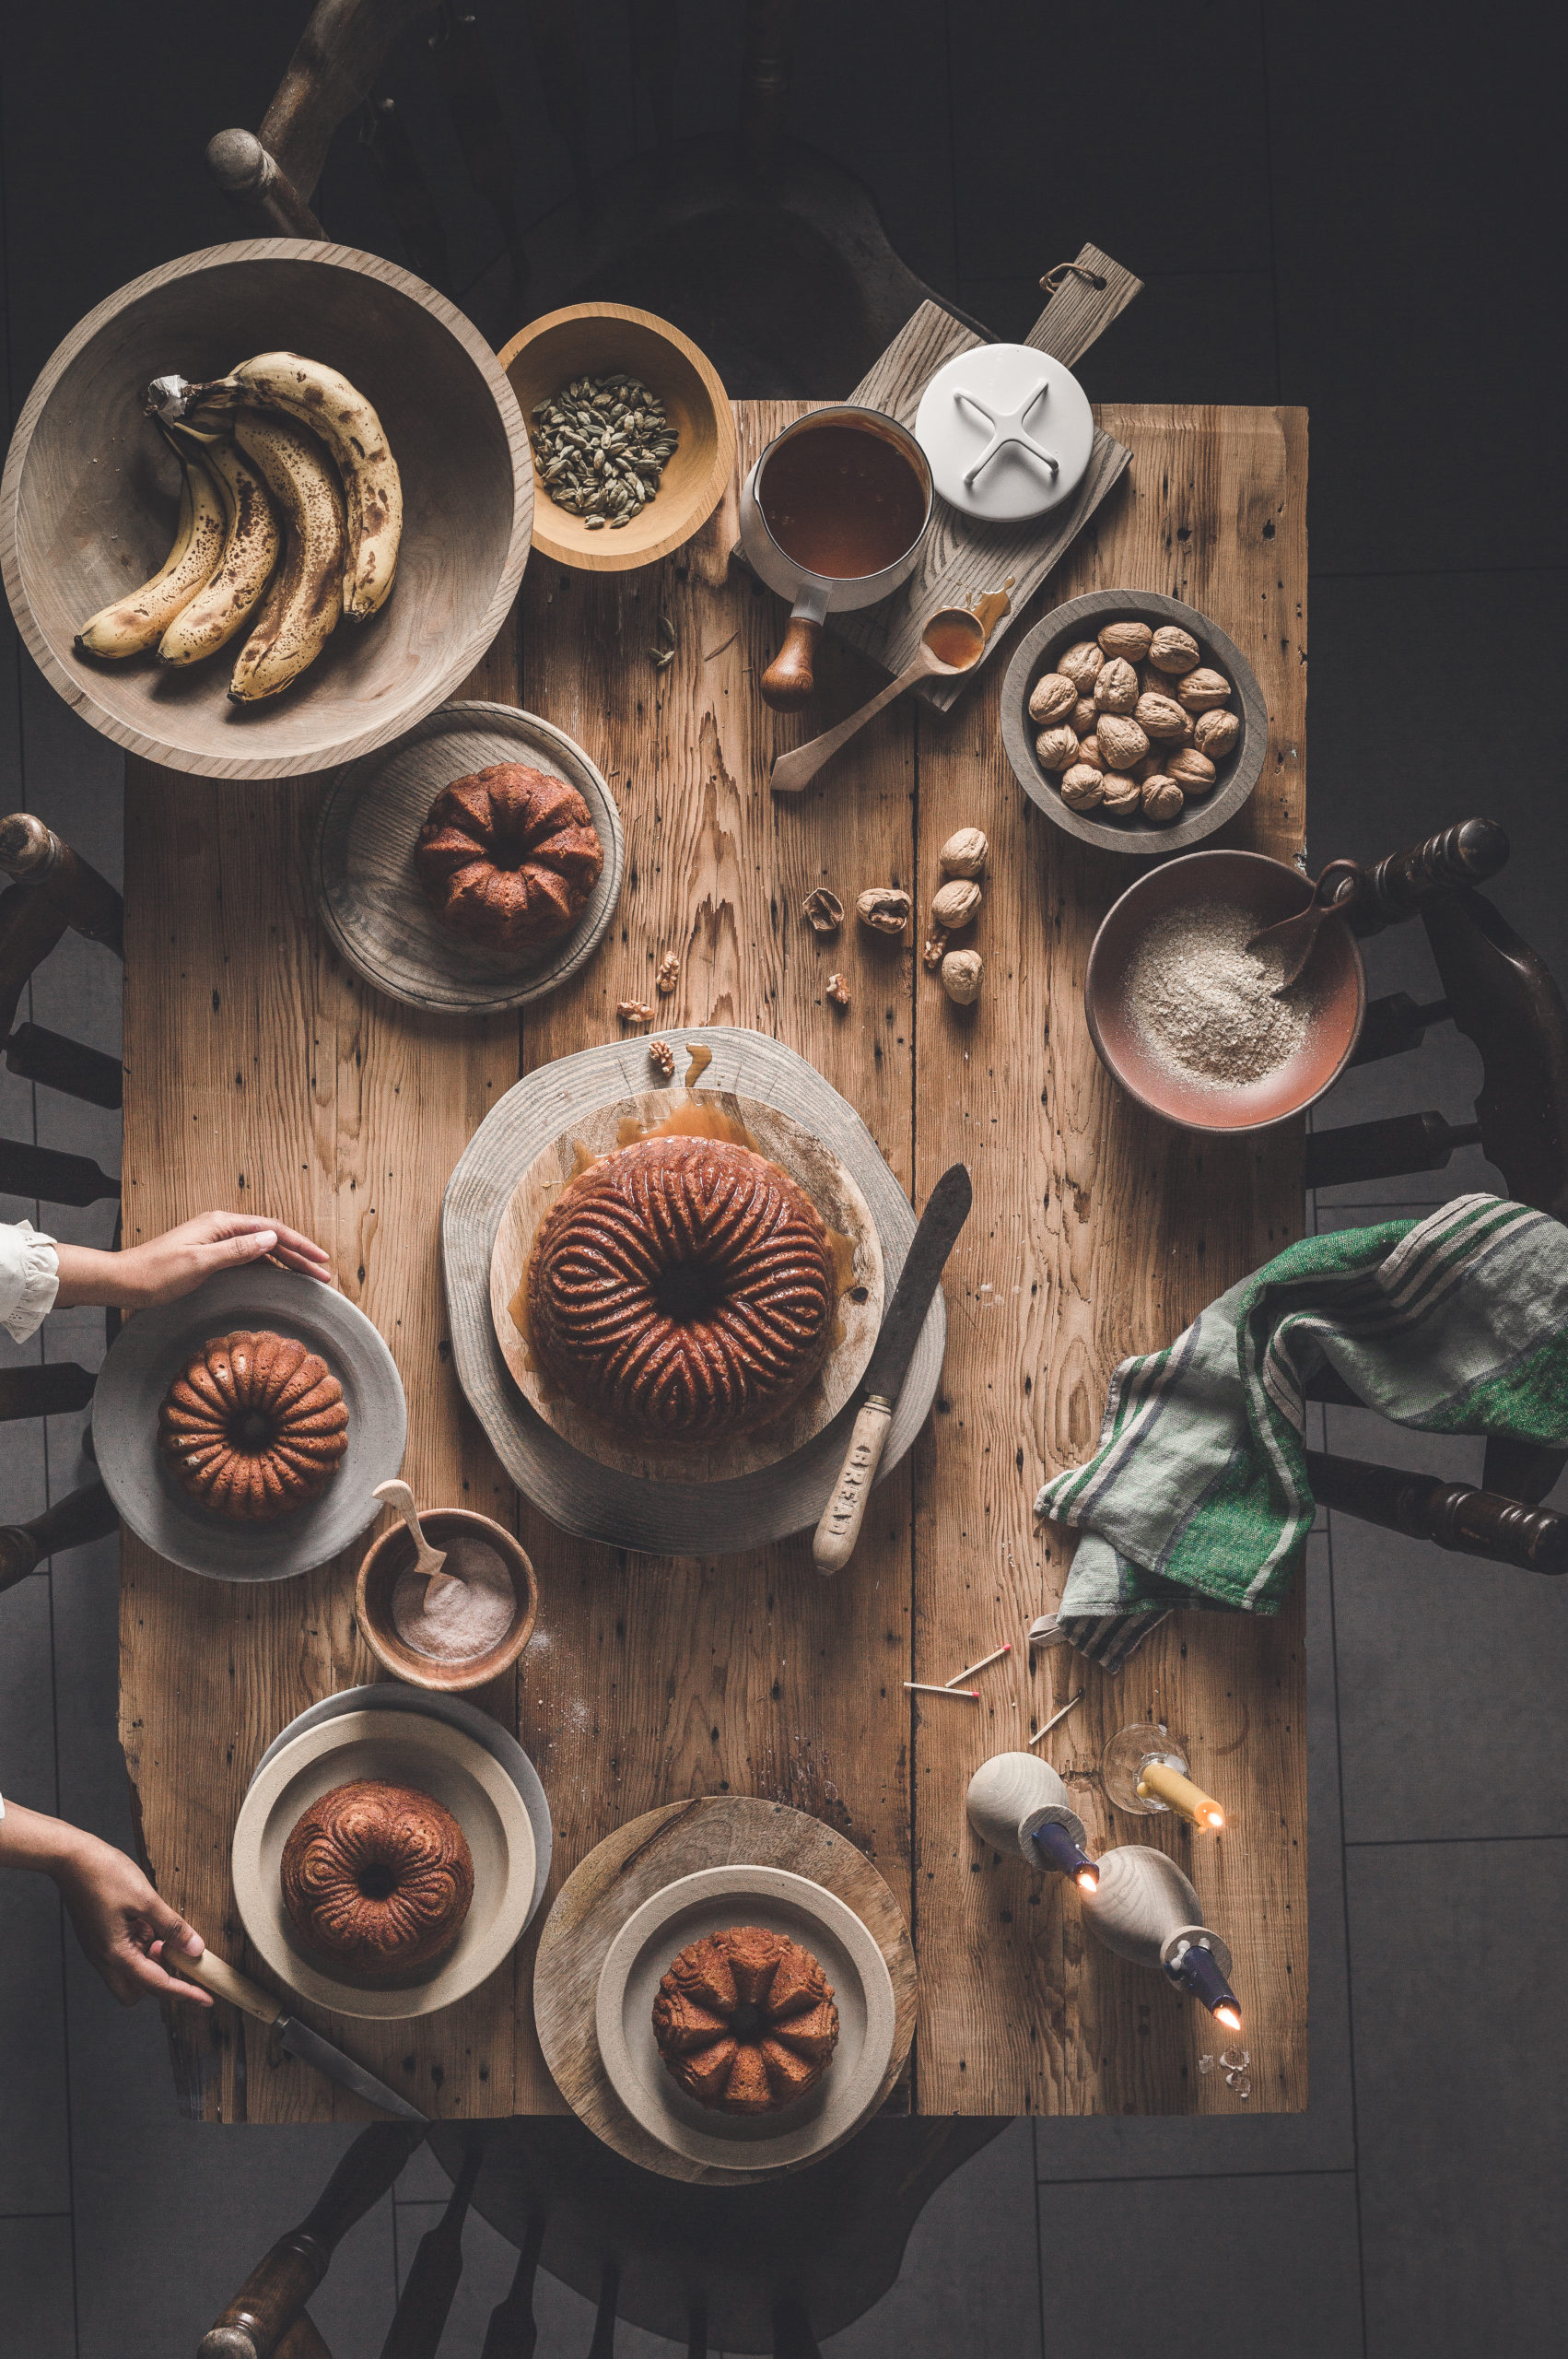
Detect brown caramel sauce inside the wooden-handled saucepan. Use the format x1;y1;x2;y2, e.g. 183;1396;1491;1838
757;420;927;581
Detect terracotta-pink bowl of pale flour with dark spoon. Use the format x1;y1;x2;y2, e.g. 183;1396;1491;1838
1084;851;1367;1130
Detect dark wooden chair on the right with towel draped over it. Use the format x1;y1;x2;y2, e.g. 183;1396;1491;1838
1306;818;1568;1574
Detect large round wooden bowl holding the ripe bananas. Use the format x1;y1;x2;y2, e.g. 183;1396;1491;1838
0;239;532;779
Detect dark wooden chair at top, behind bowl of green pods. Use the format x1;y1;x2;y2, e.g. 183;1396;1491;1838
207;0;986;399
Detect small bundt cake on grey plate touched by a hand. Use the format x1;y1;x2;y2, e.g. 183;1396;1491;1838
158;1328;349;1524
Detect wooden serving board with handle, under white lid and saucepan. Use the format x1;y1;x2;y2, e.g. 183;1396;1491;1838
825;245;1143;712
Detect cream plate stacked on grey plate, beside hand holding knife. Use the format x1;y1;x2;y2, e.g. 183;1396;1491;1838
231;1710;538;2022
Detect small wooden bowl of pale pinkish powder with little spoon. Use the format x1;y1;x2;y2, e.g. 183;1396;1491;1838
354;1508;540;1696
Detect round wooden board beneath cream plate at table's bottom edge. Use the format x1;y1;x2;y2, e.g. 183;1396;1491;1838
532;1793;915;2187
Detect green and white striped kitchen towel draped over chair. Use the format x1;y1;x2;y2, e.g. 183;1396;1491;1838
1036;1196;1568;1668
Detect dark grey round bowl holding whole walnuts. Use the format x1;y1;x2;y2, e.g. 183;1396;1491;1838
1002;590;1269;856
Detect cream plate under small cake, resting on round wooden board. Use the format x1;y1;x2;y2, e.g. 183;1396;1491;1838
594;1869;898;2170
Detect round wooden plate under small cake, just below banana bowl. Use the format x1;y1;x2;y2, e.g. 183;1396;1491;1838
313;703;627;1016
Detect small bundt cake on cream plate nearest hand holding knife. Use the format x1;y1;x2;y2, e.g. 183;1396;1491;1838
283;1778;474;1977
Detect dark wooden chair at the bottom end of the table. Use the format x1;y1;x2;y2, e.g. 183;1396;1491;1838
201;2116;1004;2359
